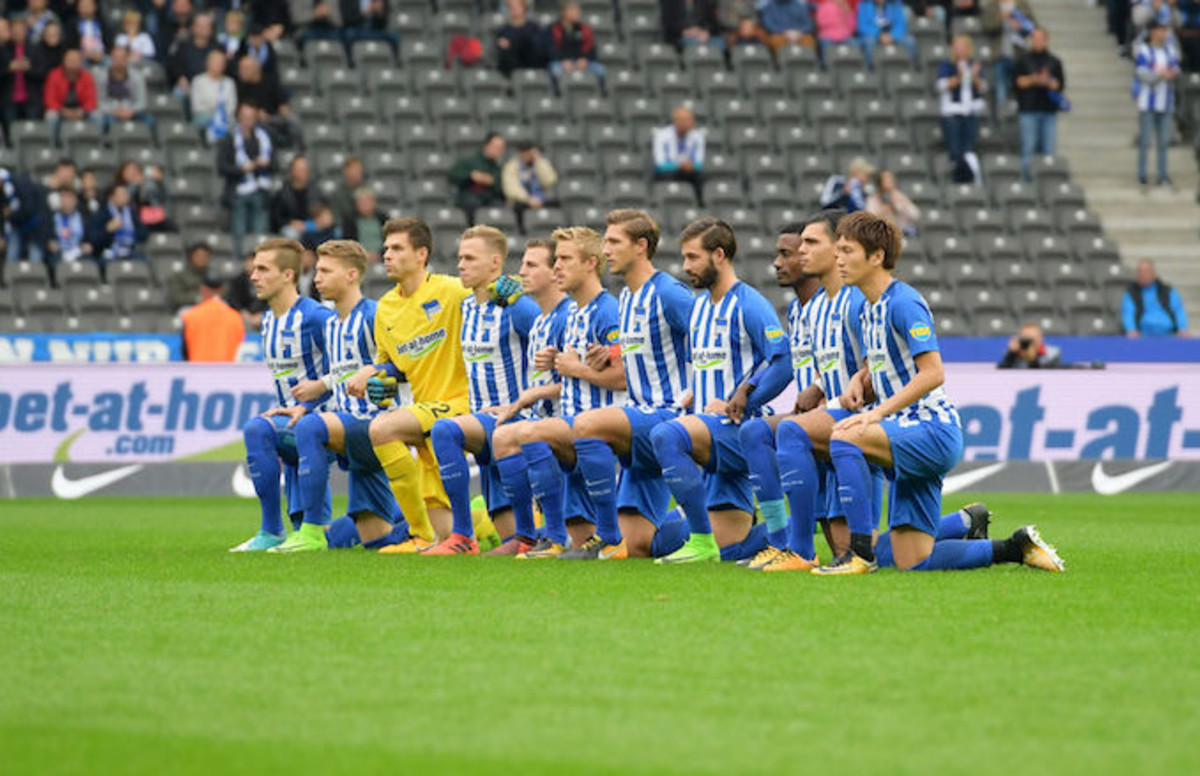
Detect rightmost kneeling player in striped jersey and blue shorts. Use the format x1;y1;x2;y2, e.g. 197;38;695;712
814;212;1064;575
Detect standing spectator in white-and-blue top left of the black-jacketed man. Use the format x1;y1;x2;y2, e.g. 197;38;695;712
937;35;988;184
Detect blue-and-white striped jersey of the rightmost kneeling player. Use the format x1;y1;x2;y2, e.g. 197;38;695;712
863;281;959;426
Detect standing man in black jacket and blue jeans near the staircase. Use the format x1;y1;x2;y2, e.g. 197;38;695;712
1013;28;1067;181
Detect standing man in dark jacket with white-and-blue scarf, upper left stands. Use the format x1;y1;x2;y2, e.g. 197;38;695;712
217;103;275;255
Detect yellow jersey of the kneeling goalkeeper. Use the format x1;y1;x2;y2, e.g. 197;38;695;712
376;272;470;403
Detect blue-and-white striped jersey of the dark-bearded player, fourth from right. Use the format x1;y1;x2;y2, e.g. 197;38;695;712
691;281;787;415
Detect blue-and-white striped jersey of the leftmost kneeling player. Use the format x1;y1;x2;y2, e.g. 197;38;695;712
259;296;334;410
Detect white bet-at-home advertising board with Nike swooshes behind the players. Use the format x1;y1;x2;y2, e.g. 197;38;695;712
0;363;1200;498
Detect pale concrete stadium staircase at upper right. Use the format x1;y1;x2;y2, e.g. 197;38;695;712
1037;0;1200;315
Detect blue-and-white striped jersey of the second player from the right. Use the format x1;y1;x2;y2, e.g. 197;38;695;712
804;285;866;401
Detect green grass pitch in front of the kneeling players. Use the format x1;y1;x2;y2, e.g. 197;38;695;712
0;494;1200;776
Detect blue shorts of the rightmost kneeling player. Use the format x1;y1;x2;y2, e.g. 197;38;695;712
880;420;962;536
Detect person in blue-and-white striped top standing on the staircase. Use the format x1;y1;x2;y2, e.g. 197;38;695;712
1133;22;1181;186
